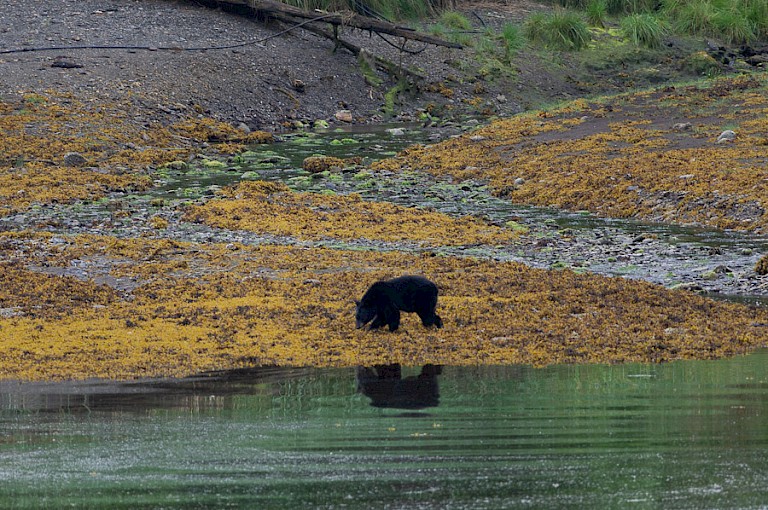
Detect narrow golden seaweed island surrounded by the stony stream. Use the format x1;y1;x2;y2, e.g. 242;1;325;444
185;181;519;247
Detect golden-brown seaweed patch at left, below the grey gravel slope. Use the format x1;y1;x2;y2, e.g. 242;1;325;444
0;93;271;215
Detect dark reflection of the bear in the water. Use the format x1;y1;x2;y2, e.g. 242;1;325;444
355;364;443;409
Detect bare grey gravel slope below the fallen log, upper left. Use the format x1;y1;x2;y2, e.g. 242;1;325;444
0;0;492;128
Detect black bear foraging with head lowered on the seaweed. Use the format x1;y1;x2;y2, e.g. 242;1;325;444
355;276;443;331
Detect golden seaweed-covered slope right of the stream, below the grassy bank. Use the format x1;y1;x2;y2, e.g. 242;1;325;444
374;77;768;232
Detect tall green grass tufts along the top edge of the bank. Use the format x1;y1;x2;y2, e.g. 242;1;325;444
276;0;768;60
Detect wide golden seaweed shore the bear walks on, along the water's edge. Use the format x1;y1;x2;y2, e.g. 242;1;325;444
0;234;768;380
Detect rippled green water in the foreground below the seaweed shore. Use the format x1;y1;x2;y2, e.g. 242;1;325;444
0;351;768;509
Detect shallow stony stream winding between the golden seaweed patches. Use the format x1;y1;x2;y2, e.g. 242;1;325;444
0;126;768;303
